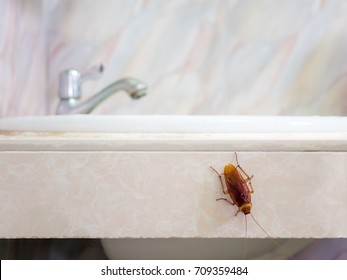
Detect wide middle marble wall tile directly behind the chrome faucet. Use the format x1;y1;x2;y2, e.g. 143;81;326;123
48;0;225;114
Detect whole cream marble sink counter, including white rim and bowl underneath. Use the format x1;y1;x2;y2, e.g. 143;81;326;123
0;115;347;259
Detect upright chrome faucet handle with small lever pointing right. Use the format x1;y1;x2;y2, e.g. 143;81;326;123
59;64;104;100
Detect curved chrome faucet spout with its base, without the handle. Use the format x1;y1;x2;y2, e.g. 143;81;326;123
57;78;147;115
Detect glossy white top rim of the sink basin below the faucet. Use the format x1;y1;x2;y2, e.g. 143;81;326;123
0;115;347;134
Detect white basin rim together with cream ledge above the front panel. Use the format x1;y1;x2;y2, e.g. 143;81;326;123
0;115;347;151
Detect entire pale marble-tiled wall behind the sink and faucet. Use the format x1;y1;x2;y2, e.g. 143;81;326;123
0;0;347;115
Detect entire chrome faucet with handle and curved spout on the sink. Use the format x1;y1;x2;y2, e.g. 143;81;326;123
56;64;147;115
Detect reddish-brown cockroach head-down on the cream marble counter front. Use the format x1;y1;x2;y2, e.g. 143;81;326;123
210;152;273;258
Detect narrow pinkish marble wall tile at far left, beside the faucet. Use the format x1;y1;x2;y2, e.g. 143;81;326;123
0;0;47;117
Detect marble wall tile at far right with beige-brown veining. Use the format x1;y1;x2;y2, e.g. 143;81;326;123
227;0;347;115
